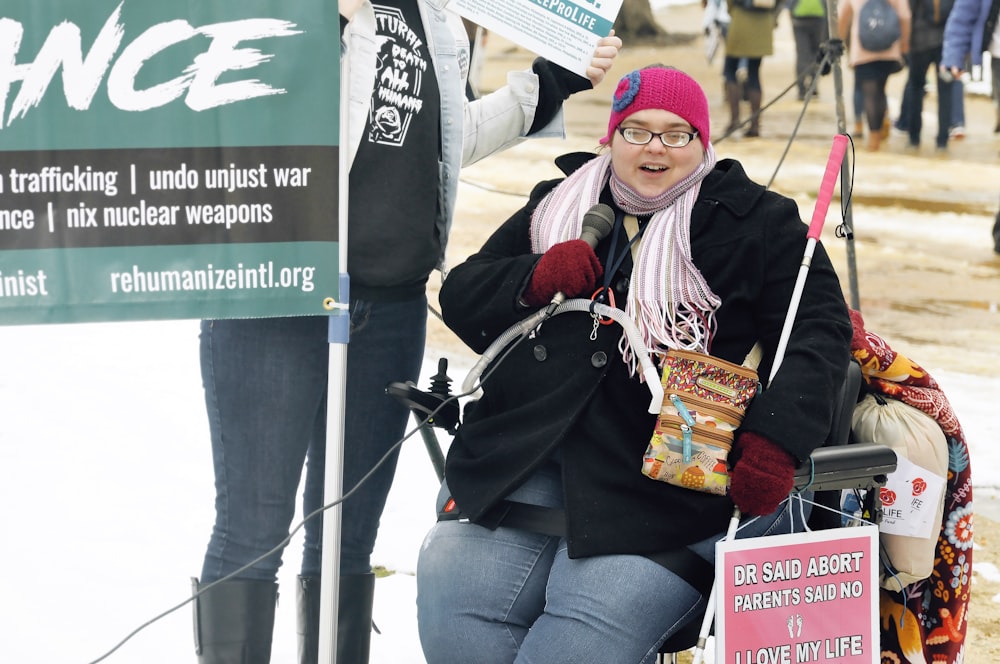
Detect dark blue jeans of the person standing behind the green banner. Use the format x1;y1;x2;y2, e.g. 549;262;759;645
201;295;427;583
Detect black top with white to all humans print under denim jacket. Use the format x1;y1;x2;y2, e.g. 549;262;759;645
347;0;441;299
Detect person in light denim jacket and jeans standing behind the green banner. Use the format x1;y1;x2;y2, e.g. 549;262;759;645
195;0;621;664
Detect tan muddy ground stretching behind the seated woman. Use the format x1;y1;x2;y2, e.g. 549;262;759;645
427;4;1000;664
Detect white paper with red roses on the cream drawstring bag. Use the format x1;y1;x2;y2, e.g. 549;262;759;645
879;454;946;538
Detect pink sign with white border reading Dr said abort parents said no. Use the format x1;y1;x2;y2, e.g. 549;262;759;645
715;526;879;664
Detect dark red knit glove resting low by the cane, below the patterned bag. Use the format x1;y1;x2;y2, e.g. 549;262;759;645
729;431;796;516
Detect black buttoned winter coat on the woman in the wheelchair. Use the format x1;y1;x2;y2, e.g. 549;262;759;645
440;153;851;557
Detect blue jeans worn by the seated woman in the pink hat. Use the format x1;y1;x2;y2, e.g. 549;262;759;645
417;470;808;664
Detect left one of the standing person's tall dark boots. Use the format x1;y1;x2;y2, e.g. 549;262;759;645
191;579;278;664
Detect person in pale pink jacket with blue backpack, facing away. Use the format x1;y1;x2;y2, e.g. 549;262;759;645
838;0;910;152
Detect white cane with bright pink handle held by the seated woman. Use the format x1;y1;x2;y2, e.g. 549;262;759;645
694;134;847;664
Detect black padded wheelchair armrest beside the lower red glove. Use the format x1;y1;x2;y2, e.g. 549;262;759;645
795;443;896;491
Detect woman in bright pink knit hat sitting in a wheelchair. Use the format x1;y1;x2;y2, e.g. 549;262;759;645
417;65;851;664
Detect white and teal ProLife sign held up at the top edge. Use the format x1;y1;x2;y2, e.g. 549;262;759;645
450;0;622;76
